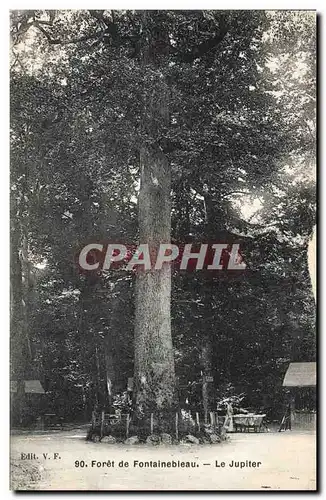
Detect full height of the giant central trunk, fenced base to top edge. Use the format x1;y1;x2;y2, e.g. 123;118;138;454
134;11;175;414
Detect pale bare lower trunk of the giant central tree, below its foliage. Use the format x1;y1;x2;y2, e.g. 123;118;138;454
135;146;175;411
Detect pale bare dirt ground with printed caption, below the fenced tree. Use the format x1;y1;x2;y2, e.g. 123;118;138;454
11;429;316;491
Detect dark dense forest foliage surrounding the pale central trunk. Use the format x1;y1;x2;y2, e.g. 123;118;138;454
11;10;316;420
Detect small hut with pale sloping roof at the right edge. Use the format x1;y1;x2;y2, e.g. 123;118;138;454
283;362;316;429
